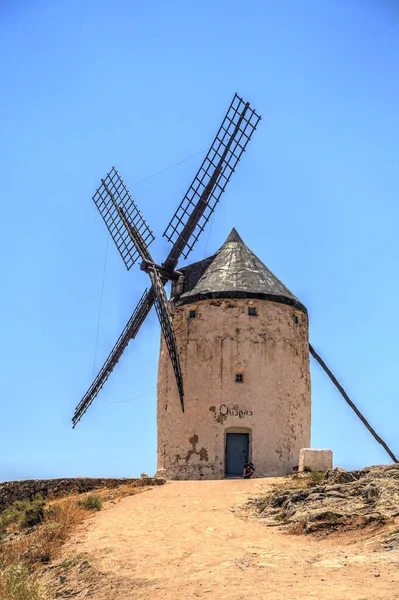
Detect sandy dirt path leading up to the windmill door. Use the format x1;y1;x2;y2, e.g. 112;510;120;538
49;479;399;600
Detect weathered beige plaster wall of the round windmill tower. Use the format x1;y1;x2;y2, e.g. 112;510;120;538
157;299;310;479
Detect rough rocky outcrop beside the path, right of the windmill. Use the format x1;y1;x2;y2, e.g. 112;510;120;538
248;464;399;548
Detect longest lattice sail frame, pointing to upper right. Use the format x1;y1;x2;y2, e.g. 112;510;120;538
163;94;261;258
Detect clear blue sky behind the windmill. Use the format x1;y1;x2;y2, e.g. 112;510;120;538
0;0;399;480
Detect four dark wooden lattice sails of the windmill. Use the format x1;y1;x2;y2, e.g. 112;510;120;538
72;94;261;427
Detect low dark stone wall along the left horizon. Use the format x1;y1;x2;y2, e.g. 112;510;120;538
0;477;165;512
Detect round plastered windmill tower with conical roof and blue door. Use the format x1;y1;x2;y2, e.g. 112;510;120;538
158;229;310;479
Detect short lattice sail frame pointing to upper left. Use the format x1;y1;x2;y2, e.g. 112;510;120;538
93;167;155;271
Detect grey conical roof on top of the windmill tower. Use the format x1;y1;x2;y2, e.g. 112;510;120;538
173;229;307;313
